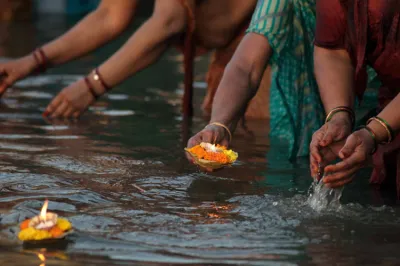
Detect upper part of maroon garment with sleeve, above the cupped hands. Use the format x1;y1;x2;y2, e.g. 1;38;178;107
315;0;400;100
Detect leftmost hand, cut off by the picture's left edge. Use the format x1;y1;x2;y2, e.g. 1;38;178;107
0;55;37;97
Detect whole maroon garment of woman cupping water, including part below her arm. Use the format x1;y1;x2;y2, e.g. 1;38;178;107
315;0;400;196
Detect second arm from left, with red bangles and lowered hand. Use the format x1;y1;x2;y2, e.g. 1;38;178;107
45;0;194;117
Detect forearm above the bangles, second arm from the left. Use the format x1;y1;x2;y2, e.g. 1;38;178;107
99;0;191;87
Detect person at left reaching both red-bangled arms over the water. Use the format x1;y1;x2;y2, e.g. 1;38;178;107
0;0;256;118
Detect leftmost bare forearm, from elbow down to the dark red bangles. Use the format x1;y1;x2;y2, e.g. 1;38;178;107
42;0;137;65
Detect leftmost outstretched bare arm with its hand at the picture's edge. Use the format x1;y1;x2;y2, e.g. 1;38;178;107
0;0;138;97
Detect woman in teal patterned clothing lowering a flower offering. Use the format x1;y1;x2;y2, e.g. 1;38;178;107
188;0;323;158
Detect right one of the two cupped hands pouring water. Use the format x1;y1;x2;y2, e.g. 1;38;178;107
322;129;375;188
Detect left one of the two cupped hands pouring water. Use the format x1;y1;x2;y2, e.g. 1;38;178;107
310;112;352;177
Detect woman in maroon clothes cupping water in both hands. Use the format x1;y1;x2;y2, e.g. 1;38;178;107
310;0;400;196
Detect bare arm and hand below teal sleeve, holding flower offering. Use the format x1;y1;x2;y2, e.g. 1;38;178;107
188;33;272;147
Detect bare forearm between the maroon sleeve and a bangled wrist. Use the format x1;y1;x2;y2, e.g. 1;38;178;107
314;47;355;112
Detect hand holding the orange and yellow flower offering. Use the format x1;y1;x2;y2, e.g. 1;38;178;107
187;125;229;148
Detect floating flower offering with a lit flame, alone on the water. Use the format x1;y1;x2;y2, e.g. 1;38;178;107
18;200;72;241
